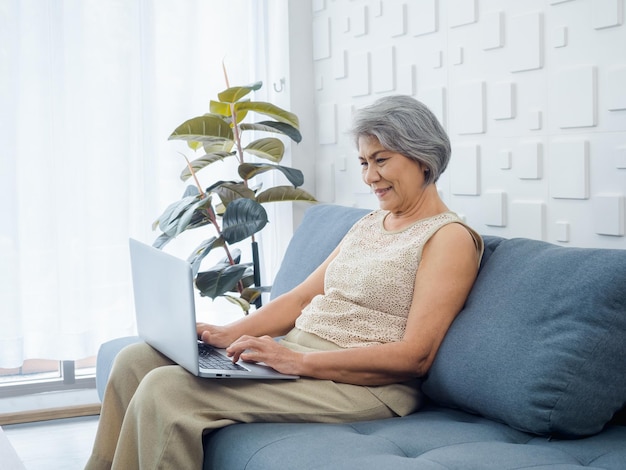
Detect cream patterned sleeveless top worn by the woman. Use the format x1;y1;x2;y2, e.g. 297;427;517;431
296;210;483;348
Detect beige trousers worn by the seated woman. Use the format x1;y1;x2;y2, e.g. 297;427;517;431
86;331;420;470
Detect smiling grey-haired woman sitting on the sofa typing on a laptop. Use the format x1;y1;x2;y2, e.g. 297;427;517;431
87;96;483;469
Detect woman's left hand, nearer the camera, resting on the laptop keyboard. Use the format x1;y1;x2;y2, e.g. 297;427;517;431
226;336;302;375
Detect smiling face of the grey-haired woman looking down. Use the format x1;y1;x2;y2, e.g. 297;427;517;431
358;136;426;214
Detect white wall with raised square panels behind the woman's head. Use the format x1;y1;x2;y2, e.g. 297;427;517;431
312;0;626;248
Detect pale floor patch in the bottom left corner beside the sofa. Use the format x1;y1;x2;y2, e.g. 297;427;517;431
0;416;98;470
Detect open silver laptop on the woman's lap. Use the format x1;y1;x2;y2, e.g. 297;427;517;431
129;238;299;379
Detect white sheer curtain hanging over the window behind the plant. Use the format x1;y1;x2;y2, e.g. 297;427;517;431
0;0;264;367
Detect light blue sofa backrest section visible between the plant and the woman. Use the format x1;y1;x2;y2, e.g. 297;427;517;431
270;204;371;298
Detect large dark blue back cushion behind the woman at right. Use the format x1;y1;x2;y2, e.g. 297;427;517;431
423;239;626;436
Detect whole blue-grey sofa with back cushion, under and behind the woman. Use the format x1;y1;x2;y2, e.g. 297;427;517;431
97;205;626;470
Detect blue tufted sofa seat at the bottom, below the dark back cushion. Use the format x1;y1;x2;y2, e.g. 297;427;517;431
204;405;626;470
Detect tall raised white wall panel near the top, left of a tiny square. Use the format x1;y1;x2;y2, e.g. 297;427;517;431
507;13;544;72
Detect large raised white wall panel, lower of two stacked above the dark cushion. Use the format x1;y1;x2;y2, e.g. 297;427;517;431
548;141;589;199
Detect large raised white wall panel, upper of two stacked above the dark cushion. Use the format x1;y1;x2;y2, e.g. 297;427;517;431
553;66;598;129
